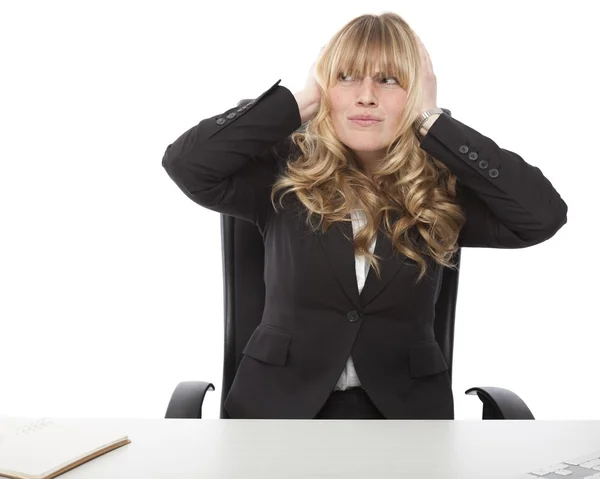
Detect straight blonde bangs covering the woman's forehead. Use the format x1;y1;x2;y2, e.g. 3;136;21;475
329;20;409;88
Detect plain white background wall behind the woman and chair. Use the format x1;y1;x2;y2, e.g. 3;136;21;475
0;0;600;419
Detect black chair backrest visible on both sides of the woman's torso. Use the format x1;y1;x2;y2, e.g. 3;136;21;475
220;215;461;419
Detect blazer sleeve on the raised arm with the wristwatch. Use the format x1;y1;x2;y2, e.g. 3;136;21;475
420;114;567;248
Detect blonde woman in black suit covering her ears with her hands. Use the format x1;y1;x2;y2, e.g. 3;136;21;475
163;13;567;419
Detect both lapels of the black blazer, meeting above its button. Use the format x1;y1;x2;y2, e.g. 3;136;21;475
318;216;408;309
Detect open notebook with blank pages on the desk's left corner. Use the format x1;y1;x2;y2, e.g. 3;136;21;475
0;417;131;479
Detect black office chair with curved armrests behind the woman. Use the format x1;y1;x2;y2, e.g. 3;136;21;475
165;100;535;419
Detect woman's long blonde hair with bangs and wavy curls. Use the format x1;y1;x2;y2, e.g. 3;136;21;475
271;13;465;282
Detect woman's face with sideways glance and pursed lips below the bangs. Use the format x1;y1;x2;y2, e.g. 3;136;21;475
329;70;407;172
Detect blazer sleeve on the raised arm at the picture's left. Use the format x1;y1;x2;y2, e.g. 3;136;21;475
162;80;301;230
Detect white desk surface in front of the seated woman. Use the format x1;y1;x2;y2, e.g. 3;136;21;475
1;418;600;479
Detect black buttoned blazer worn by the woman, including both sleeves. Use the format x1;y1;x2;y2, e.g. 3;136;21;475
162;81;567;419
